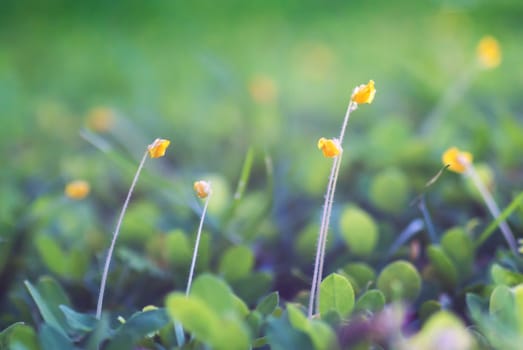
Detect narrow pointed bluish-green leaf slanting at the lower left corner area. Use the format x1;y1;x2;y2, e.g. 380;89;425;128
24;281;67;337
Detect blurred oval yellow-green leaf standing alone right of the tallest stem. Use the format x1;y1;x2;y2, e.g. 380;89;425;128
340;206;379;256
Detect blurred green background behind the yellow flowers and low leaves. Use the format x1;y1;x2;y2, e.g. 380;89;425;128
0;0;523;322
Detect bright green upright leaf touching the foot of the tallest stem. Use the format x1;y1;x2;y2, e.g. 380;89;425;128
319;273;354;318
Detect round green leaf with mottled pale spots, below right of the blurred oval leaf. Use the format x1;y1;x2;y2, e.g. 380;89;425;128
377;260;421;302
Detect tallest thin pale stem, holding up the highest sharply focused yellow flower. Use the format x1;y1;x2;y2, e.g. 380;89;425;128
308;100;358;318
